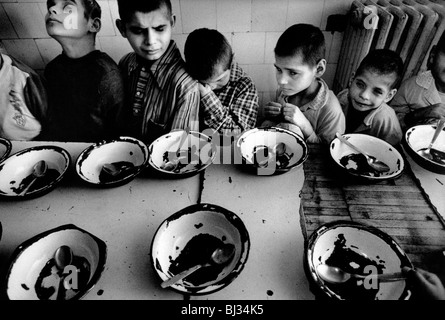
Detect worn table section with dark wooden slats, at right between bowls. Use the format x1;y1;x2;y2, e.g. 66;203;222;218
301;145;445;283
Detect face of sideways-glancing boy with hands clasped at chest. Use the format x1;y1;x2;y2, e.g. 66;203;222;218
275;55;317;96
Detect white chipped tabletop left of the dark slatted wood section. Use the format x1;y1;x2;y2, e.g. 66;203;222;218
0;142;314;300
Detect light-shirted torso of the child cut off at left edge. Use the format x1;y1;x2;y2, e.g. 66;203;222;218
0;51;47;140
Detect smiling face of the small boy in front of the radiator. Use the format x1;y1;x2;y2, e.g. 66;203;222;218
349;70;397;111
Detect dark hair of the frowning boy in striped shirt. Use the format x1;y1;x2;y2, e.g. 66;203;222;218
117;0;173;22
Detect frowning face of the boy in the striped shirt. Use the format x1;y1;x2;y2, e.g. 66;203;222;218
117;7;175;61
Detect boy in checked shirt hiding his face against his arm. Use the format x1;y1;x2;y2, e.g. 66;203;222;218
184;28;258;135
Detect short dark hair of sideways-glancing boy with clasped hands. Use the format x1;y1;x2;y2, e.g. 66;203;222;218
275;23;326;67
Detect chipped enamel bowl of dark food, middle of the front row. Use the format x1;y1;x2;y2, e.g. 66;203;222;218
151;204;250;295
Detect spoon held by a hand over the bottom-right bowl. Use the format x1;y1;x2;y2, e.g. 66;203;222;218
317;264;406;283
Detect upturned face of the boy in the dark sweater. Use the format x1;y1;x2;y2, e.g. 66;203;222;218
45;0;90;38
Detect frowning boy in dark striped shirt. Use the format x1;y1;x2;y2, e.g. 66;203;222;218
116;0;199;144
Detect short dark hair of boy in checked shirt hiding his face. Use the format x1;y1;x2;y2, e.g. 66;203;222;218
184;28;232;80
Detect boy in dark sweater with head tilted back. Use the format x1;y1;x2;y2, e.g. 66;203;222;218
40;0;124;142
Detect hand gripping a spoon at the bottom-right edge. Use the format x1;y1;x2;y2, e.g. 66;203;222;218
403;267;445;300
